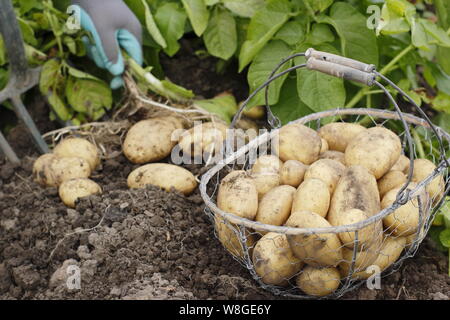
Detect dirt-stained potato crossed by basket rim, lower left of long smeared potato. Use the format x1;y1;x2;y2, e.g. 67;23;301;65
286;211;342;267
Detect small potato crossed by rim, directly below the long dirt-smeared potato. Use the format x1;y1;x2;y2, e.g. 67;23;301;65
337;209;383;248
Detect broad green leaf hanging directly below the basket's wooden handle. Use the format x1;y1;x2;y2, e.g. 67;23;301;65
295;44;346;112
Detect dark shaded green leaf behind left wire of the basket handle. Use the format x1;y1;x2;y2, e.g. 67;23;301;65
271;78;314;125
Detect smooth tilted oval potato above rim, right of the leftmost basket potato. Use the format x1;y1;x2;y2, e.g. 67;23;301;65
255;186;296;226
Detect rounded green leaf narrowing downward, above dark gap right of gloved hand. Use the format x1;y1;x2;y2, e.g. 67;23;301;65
155;3;187;57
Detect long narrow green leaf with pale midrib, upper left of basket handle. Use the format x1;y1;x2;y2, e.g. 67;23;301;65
239;0;291;72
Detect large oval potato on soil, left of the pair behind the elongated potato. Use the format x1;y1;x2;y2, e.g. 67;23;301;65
123;117;183;164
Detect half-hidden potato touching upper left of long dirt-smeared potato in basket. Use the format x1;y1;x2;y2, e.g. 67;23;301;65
304;159;345;194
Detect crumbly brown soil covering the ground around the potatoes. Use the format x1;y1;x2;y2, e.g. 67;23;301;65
0;42;450;300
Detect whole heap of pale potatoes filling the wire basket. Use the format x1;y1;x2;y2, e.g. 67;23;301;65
215;122;444;296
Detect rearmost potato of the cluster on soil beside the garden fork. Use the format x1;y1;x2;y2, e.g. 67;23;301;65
53;138;100;171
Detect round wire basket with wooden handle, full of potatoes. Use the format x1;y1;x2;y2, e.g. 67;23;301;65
200;49;450;299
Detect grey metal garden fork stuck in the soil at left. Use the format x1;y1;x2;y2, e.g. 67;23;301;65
0;0;49;164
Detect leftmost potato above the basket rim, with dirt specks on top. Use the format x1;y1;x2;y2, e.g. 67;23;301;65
217;171;258;220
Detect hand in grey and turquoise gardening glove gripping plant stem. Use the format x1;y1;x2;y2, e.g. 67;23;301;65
72;0;143;89
